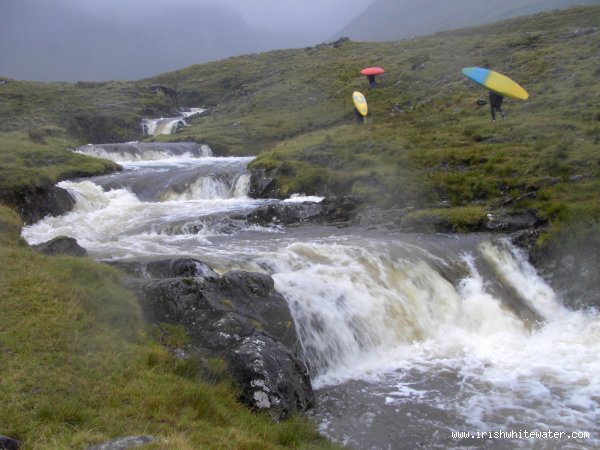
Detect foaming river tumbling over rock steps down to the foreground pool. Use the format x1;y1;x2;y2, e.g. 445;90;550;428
23;143;600;449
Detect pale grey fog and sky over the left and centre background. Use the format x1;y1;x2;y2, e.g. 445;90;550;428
0;0;373;81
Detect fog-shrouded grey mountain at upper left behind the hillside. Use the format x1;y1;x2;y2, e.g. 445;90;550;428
0;0;314;81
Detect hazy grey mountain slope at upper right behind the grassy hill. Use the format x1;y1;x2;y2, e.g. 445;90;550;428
335;0;600;41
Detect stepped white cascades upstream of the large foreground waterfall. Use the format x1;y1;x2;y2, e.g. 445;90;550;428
24;142;270;259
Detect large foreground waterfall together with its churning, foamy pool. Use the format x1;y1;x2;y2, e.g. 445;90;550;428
251;239;600;448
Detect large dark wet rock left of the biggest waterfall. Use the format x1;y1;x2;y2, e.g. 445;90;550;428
130;259;313;419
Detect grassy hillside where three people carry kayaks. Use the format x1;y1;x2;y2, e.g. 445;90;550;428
148;7;600;234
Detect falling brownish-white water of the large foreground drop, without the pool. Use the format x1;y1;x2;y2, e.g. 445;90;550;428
255;237;563;385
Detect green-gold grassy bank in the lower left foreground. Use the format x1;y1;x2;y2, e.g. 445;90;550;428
0;207;340;449
